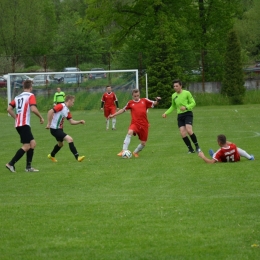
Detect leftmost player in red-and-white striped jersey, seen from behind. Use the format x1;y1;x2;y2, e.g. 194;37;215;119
5;80;44;172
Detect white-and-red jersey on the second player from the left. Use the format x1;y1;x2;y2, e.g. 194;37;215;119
50;103;72;129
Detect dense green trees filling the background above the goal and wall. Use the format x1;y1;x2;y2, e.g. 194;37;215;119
0;0;260;105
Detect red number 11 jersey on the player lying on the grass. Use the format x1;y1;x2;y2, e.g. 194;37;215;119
213;144;240;162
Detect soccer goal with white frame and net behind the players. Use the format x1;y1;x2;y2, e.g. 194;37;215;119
6;68;139;111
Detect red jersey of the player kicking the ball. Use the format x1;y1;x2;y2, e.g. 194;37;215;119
123;98;154;127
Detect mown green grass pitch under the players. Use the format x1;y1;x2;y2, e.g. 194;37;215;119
0;105;260;260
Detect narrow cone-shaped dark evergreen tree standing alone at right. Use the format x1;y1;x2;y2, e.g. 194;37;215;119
221;30;246;104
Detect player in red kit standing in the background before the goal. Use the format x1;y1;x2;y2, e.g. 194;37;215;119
100;86;119;130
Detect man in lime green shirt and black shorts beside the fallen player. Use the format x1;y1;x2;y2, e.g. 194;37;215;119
162;79;201;153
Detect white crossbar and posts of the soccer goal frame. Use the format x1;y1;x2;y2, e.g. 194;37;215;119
7;69;139;106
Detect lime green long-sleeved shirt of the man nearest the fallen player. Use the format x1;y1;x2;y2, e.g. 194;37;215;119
165;90;196;115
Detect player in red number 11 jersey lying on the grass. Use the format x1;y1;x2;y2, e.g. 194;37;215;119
198;134;255;163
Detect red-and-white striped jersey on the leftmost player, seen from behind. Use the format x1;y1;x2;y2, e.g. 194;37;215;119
9;92;36;127
